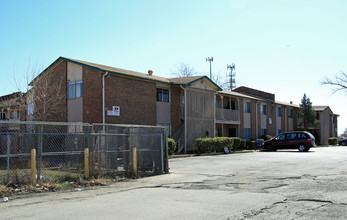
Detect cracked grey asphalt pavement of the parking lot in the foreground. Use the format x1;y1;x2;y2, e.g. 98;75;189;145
0;147;347;219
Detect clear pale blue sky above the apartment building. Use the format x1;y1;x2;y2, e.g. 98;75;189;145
0;0;347;132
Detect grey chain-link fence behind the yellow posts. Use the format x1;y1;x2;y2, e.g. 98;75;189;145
0;121;168;184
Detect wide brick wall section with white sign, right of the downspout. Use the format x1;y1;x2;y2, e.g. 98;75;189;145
105;75;157;125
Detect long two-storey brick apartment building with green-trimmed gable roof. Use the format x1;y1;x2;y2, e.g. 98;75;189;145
1;57;337;152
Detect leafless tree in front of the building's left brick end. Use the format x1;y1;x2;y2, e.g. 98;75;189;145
13;59;67;121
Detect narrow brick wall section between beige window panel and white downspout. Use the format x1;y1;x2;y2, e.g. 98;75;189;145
82;67;105;123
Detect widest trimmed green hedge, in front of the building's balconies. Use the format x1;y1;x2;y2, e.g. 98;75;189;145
194;137;234;154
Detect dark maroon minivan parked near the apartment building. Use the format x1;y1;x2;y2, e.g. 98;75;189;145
263;131;316;152
